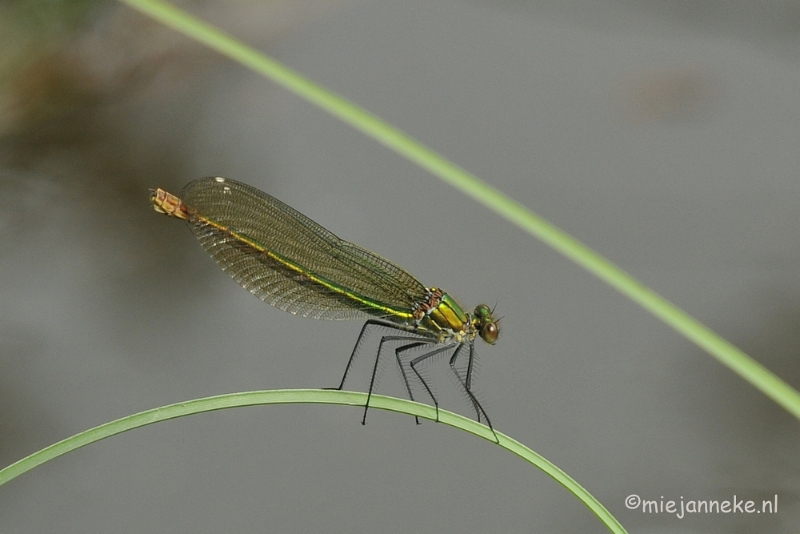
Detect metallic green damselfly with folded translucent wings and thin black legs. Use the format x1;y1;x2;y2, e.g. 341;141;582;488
151;177;499;438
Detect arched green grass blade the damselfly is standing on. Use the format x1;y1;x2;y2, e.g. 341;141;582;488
0;389;625;533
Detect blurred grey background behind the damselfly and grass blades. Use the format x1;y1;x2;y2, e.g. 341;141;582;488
0;0;800;534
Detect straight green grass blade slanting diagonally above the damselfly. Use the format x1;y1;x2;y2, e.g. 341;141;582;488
121;0;800;419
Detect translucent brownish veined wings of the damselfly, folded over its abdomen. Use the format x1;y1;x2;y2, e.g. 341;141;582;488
181;178;427;319
